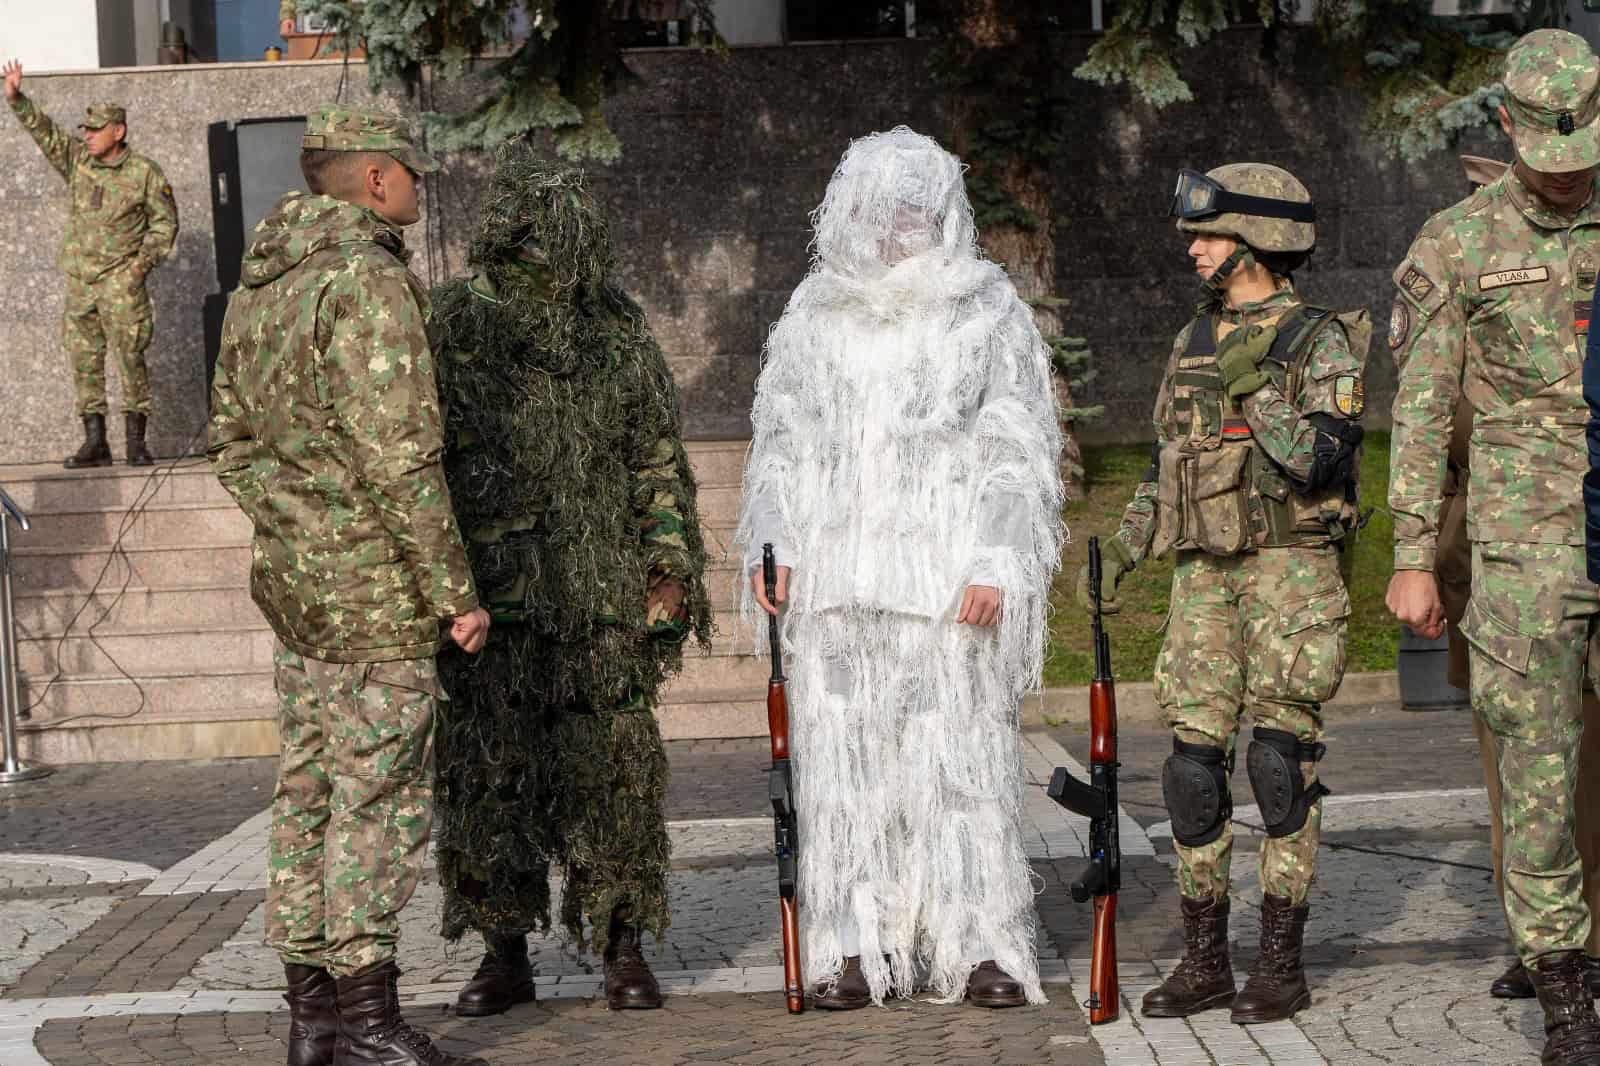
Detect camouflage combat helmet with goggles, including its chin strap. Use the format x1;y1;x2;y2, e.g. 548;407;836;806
1170;163;1317;288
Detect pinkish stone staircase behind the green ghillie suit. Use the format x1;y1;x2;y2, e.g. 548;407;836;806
0;442;766;763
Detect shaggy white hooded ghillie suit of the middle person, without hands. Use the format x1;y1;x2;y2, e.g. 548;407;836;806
738;126;1066;1002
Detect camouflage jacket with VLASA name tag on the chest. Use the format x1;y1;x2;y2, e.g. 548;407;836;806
1389;171;1600;570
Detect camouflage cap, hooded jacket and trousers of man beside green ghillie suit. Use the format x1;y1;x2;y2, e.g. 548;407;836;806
211;107;477;976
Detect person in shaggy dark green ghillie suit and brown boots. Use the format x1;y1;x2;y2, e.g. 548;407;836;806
432;141;712;1015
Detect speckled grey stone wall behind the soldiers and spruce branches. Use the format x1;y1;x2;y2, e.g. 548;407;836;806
0;30;1498;464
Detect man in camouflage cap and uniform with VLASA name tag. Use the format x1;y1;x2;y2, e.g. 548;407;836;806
1387;30;1600;1064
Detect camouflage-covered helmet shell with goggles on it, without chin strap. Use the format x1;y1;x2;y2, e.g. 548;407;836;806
1173;163;1317;251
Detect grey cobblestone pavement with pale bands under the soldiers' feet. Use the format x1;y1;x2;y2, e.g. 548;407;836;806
0;707;1561;1066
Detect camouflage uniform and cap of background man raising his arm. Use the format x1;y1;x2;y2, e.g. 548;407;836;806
11;93;178;415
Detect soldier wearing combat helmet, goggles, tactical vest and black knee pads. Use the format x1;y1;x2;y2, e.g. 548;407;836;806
1078;163;1371;1024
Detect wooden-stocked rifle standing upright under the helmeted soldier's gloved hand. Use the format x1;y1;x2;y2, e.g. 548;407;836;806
1048;536;1122;1024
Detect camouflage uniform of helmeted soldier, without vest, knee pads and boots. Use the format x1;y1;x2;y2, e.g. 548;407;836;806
1117;285;1363;906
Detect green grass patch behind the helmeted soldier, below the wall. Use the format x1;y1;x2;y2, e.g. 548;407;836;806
1045;431;1400;687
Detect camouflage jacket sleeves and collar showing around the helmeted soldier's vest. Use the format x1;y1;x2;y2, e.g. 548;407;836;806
1117;285;1365;560
